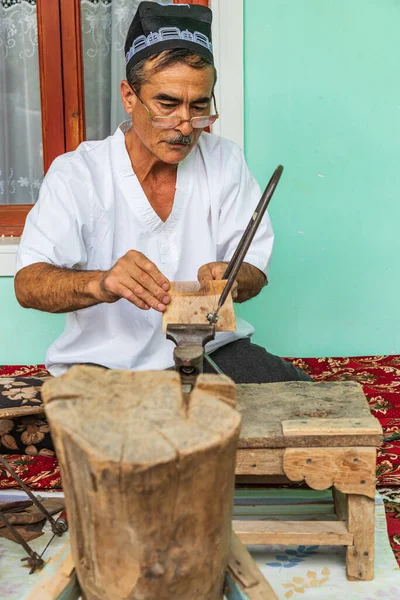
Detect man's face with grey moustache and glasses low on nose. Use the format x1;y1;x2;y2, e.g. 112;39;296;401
122;63;214;164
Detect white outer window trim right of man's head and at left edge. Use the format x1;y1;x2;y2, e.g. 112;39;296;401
0;0;244;277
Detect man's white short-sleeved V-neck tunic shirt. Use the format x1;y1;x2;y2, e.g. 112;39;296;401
17;123;273;375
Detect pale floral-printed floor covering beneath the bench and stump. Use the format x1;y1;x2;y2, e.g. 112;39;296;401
0;489;400;600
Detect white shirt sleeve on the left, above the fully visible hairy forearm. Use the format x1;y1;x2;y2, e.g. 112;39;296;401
16;155;92;272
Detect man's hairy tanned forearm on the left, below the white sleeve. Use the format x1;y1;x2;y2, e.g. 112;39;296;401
14;263;103;313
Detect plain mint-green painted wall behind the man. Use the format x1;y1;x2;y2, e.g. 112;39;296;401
0;0;400;364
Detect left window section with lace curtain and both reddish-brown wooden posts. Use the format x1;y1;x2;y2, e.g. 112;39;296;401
0;0;83;236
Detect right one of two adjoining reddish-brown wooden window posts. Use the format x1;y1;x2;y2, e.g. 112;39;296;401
60;0;86;152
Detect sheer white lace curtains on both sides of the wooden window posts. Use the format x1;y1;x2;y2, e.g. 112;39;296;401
0;0;171;204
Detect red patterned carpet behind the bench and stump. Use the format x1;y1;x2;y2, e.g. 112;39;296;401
0;355;400;565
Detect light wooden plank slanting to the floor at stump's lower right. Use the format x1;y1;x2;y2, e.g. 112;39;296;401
228;532;278;600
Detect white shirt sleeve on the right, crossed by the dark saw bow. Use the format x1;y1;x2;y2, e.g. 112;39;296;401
217;146;274;274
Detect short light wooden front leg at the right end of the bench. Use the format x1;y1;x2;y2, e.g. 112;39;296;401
346;494;375;581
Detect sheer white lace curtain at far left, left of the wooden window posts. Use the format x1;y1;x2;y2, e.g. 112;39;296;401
0;0;43;204
